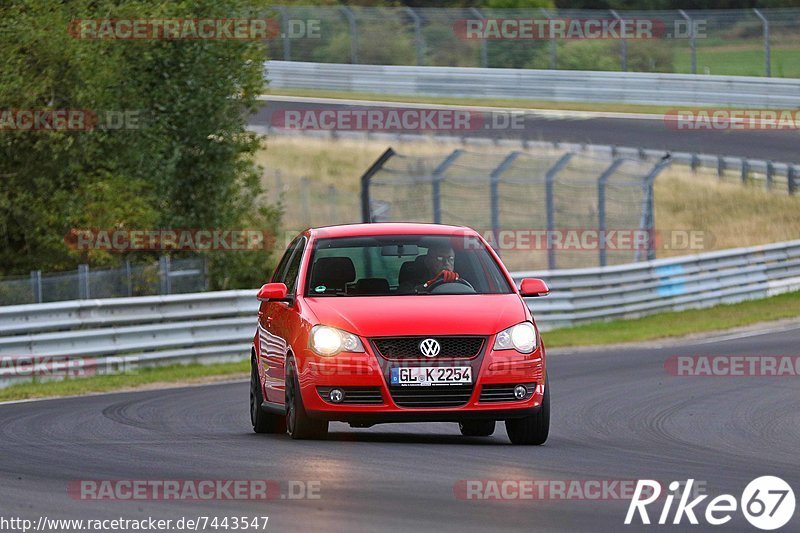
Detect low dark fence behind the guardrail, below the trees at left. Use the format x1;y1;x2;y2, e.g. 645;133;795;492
0;256;208;305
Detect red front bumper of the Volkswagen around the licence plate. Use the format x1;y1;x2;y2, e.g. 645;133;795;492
298;338;545;424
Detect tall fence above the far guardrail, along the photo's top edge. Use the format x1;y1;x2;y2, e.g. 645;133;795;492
268;6;800;77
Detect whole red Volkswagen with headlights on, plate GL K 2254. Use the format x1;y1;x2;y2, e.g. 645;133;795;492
250;223;550;444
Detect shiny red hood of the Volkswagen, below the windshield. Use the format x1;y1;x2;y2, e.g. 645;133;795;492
305;294;527;337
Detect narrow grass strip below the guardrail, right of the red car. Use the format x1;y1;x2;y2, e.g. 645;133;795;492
542;291;800;348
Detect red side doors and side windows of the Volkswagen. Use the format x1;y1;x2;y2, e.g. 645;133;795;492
259;237;306;403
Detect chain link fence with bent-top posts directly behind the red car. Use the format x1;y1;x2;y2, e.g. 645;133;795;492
362;149;670;270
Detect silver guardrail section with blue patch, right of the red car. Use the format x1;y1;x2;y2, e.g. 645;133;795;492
513;241;800;329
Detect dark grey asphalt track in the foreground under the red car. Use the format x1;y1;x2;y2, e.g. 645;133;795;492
0;324;800;532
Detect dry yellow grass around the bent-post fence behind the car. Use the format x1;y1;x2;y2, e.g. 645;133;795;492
258;136;800;260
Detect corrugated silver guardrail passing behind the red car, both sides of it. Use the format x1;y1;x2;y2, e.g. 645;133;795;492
0;241;800;387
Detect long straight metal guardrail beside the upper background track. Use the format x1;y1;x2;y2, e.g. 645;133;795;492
265;61;800;109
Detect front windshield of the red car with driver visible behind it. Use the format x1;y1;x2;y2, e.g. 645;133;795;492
306;235;512;296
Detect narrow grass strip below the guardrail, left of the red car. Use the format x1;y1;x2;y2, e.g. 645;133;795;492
0;361;250;401
